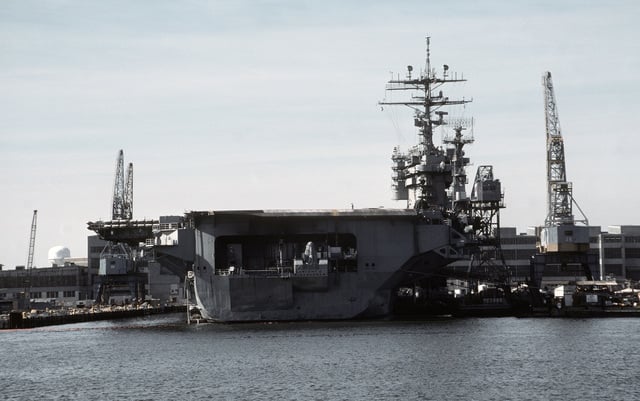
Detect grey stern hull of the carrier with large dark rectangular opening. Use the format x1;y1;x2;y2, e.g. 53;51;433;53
193;209;457;322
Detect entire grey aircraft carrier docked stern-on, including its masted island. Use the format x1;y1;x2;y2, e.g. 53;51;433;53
89;39;503;322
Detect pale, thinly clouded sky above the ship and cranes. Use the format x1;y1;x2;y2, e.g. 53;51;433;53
0;0;640;269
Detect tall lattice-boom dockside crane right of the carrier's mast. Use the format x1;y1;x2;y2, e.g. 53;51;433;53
531;72;596;287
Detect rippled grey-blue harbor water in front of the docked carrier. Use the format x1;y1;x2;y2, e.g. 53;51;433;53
0;314;640;400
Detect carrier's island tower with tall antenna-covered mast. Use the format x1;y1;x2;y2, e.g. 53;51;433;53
380;38;473;222
